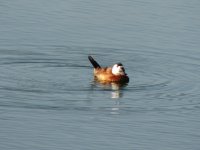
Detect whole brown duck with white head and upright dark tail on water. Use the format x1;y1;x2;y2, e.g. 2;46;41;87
88;56;129;84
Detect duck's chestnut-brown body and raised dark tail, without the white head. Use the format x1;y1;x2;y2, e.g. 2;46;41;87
88;56;129;83
